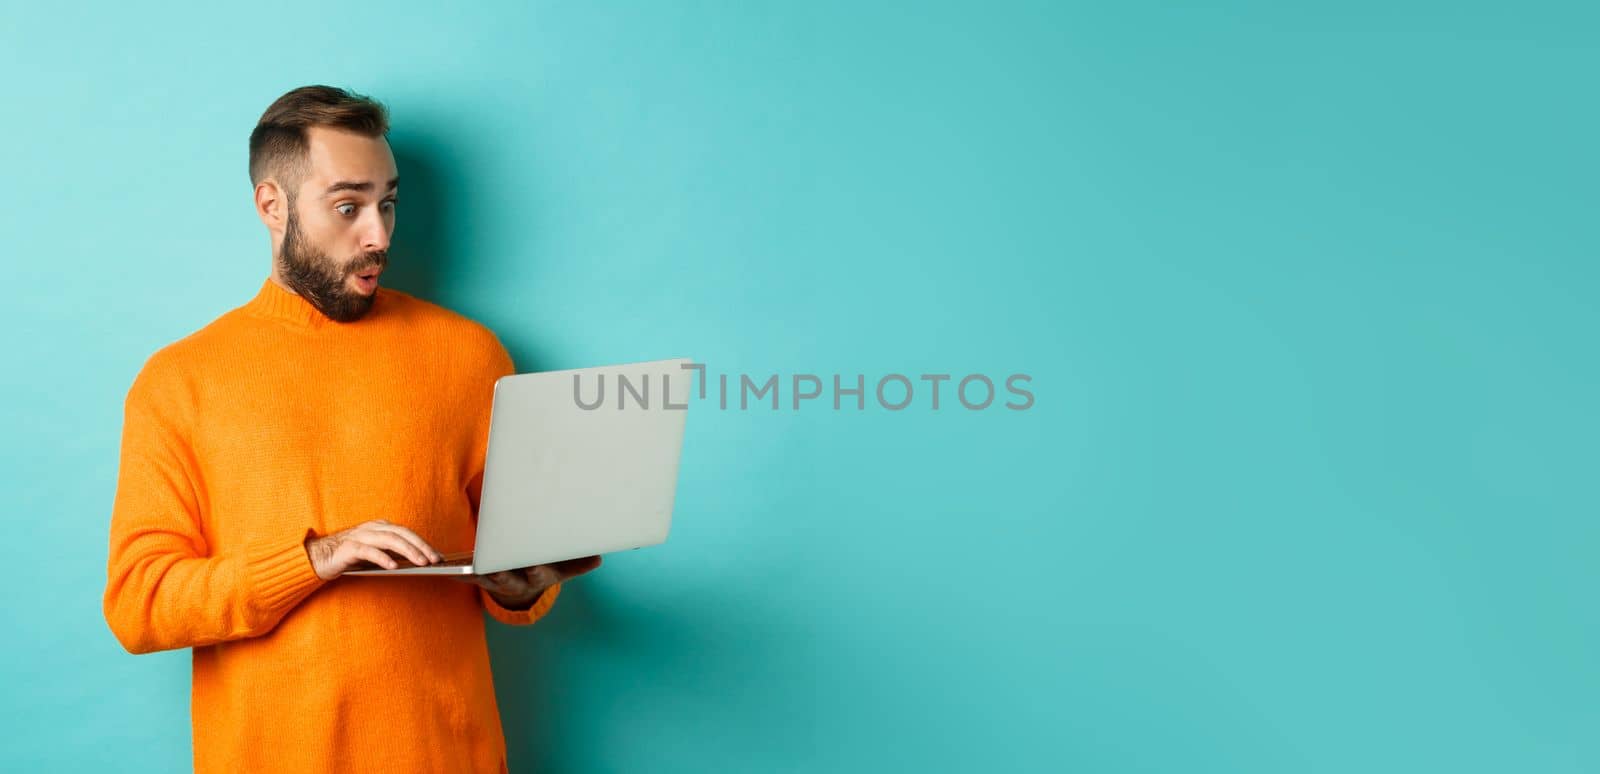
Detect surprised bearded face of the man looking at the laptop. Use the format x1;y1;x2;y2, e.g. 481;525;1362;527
278;126;398;323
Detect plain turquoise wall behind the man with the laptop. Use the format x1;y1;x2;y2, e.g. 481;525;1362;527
0;2;1600;772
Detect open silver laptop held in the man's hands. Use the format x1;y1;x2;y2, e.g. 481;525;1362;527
344;358;693;576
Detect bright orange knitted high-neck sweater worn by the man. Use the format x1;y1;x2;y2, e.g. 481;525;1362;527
104;280;560;774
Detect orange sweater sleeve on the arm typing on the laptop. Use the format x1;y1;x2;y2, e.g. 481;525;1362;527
102;360;326;654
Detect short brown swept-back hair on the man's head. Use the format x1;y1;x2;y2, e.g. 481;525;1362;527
250;86;389;203
